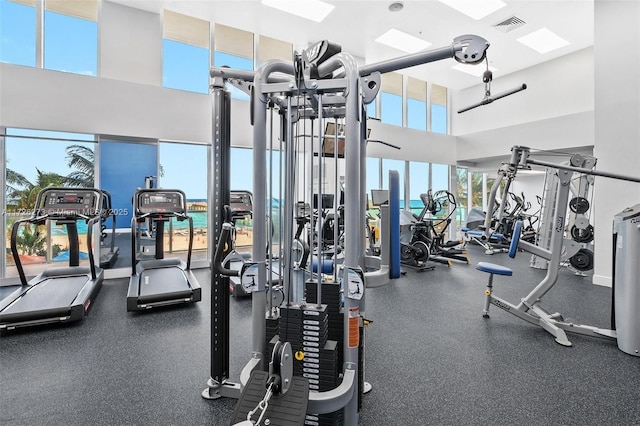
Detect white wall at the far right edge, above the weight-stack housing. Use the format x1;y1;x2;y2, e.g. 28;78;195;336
593;0;640;285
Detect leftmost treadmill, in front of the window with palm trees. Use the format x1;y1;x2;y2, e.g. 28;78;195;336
0;187;104;331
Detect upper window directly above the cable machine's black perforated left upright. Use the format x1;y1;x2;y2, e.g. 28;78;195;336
213;24;253;100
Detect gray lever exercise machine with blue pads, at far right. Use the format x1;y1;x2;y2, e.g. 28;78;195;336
477;146;640;356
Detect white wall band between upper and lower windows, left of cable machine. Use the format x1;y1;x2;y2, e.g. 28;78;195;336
0;63;211;143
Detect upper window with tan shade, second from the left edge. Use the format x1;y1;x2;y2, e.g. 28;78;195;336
44;0;98;76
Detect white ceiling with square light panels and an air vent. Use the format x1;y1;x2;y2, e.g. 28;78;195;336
111;0;593;89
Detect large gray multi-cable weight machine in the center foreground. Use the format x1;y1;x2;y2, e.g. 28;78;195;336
202;35;489;426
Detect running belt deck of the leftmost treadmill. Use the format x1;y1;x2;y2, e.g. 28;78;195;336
1;275;88;322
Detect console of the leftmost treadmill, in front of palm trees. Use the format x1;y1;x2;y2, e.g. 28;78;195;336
36;188;102;217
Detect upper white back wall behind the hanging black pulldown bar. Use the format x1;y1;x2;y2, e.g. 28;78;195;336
451;48;594;169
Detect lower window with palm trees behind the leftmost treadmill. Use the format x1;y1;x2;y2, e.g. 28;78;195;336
4;129;95;277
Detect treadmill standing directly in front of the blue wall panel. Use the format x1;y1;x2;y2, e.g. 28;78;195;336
127;189;202;312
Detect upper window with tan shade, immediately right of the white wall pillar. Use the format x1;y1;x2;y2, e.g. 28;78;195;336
162;10;210;93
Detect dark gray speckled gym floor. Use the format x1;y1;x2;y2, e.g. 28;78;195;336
0;247;640;426
